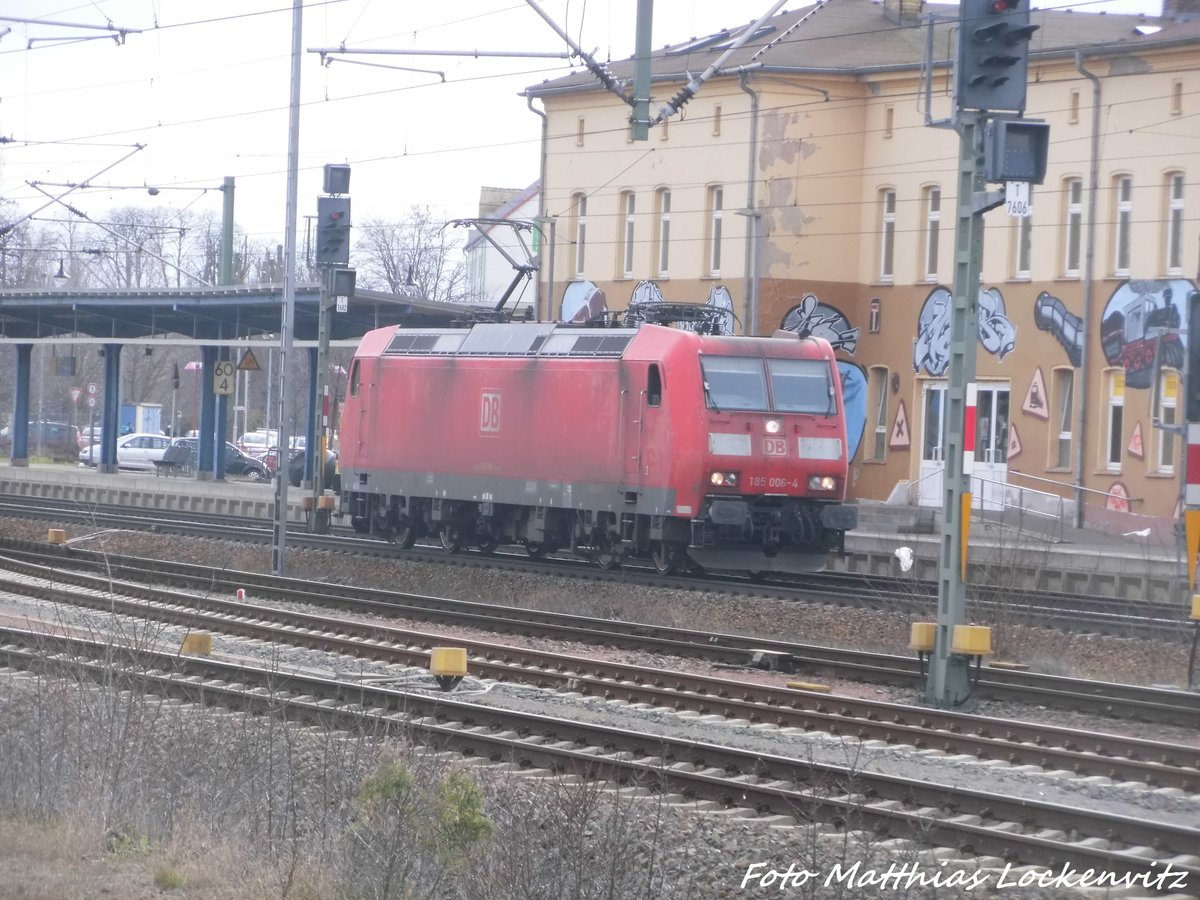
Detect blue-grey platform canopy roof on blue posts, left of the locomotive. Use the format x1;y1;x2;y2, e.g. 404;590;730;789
0;284;492;343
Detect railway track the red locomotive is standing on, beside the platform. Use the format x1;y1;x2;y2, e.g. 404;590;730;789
0;498;1192;643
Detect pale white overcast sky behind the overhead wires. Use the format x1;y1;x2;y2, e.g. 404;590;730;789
0;0;1160;250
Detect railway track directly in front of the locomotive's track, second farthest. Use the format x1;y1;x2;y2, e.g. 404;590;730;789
6;546;1200;730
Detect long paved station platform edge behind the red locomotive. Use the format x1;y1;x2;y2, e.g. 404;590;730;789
0;463;1192;610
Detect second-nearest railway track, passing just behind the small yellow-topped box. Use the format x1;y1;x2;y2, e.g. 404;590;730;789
4;549;1200;793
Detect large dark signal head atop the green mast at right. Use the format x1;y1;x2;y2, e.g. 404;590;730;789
954;0;1039;113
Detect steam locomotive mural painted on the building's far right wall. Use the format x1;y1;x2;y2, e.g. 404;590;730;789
1100;278;1192;390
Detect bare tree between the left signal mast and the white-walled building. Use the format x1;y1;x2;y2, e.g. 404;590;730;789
354;206;467;302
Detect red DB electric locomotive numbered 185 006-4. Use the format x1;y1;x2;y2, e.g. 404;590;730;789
341;323;858;571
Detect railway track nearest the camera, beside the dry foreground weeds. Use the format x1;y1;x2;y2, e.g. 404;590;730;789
0;629;1200;890
